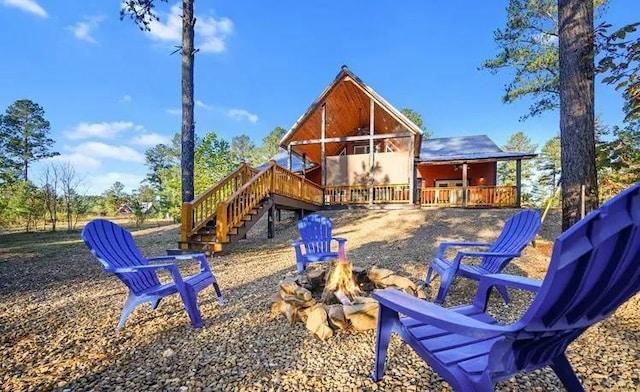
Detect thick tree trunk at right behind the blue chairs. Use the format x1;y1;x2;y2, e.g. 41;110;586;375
558;0;598;230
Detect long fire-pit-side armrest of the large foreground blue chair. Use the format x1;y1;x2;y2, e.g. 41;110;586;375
373;288;512;338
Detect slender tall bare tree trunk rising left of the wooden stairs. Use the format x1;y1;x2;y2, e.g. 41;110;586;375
181;0;196;202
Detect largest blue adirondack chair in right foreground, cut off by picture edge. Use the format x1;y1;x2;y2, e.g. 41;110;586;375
373;184;640;391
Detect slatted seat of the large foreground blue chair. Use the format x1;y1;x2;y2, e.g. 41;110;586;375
400;305;503;375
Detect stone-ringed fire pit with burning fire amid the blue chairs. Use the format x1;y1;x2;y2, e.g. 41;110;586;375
271;260;425;340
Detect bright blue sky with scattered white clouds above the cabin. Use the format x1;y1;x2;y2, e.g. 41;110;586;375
0;0;640;194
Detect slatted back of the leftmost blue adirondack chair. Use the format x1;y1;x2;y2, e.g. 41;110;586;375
82;219;160;294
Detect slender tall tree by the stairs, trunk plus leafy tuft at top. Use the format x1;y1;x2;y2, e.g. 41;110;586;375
120;0;196;202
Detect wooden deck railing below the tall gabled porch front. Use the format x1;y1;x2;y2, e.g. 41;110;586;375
324;184;409;205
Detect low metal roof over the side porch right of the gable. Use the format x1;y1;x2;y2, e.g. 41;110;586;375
420;135;537;162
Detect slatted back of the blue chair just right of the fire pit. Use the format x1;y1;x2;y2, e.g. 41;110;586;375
480;210;541;274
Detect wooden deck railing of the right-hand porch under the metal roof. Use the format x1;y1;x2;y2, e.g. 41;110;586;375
420;186;517;207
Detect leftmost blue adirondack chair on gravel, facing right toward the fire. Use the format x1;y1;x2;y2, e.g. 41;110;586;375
82;219;224;330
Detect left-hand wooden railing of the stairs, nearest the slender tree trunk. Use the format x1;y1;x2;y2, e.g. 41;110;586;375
180;162;258;241
